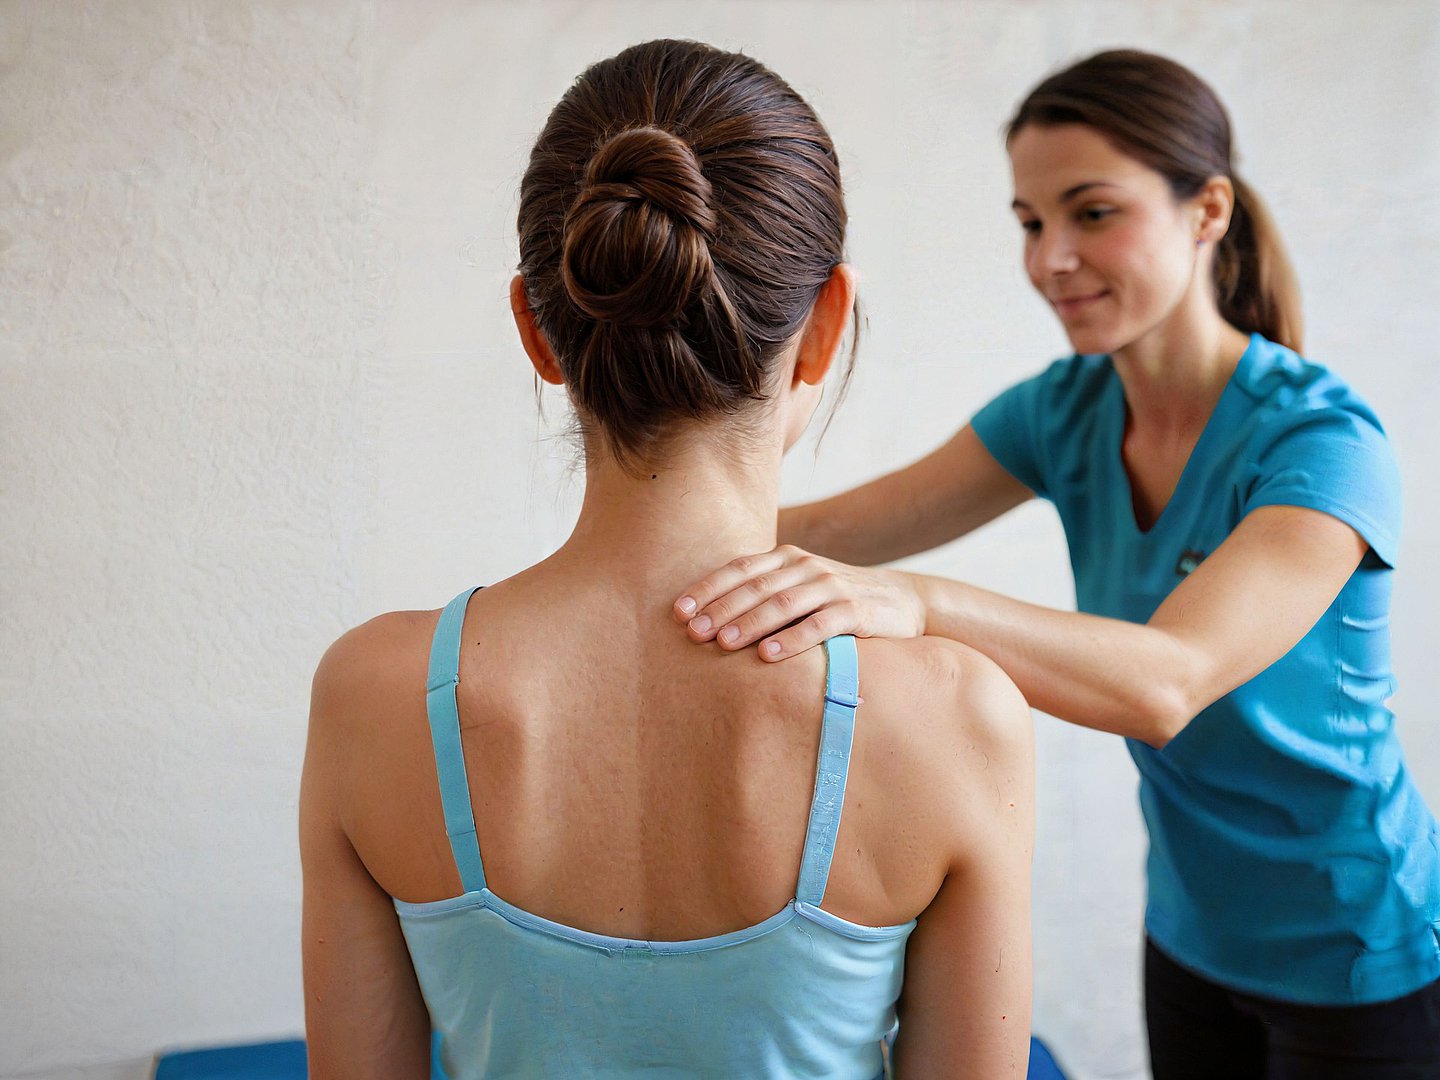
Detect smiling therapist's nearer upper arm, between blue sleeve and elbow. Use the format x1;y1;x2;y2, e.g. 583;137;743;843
1148;505;1368;737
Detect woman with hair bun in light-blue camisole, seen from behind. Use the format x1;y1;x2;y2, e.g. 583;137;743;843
301;42;1034;1080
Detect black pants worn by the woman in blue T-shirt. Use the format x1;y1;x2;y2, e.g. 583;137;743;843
1145;940;1440;1080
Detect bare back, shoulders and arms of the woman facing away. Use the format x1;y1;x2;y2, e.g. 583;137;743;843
301;550;1034;1079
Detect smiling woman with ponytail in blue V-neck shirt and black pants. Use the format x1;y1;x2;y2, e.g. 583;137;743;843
675;50;1440;1080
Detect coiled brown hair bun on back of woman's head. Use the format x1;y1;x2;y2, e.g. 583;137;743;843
560;127;716;327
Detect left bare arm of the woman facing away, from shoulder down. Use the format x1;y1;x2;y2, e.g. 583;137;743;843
300;631;429;1080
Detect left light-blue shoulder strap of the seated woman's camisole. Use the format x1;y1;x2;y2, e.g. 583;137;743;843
425;589;485;893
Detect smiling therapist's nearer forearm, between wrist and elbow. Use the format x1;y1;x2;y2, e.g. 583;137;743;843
912;575;1218;746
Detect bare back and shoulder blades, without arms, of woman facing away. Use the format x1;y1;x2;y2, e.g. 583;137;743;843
331;566;1019;940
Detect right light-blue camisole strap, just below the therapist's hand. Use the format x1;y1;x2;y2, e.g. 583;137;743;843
795;635;860;906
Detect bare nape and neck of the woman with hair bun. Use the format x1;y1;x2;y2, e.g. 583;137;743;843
553;436;783;600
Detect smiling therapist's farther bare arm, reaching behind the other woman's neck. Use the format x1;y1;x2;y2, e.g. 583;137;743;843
780;425;1034;566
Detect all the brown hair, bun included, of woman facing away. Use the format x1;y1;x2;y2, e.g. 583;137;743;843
518;40;845;469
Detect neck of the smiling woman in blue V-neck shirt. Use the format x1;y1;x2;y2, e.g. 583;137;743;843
1112;295;1250;428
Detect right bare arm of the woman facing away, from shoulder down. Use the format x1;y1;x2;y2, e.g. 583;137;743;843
896;642;1035;1080
